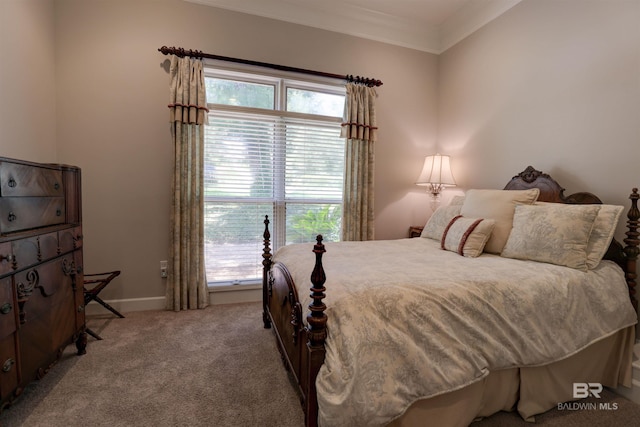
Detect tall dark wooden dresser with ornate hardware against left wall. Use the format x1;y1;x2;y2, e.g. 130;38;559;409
0;157;87;411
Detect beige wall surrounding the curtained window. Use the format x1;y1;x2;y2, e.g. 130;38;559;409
50;0;437;299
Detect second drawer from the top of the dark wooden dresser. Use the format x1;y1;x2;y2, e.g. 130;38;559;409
0;197;66;233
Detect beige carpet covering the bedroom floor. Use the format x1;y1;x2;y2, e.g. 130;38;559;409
0;303;640;427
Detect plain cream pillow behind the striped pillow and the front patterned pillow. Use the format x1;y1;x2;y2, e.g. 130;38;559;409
460;188;540;254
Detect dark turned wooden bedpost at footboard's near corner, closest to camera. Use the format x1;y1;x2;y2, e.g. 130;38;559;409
304;234;327;426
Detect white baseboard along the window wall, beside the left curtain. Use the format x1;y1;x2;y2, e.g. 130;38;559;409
85;285;262;316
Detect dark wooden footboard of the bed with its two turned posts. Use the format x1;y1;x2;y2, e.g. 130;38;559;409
262;216;327;427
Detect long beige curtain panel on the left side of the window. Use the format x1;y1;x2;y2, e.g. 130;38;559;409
166;55;209;311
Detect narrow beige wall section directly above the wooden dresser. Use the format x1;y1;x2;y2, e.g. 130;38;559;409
0;0;57;163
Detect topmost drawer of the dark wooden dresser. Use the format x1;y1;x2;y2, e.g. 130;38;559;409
0;162;64;197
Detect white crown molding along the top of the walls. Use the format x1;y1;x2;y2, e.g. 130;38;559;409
184;0;522;54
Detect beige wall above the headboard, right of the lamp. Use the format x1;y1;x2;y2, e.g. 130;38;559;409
438;0;640;241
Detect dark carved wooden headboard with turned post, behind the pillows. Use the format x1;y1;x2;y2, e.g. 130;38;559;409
504;166;640;312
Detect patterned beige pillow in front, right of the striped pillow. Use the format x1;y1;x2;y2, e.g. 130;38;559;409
501;203;600;271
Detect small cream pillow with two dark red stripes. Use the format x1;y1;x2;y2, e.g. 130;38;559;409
440;215;496;258
